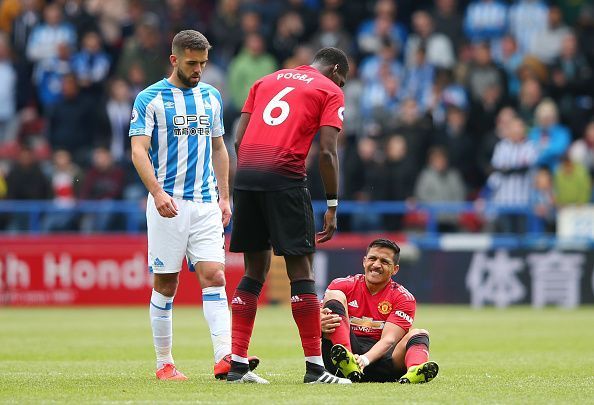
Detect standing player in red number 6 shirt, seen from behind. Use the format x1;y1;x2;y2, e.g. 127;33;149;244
227;48;351;384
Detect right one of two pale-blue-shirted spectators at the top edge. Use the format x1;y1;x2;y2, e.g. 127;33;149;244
509;0;549;52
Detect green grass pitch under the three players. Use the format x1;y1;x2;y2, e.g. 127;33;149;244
0;305;594;405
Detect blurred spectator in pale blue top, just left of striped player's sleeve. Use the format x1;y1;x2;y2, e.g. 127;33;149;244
105;79;132;163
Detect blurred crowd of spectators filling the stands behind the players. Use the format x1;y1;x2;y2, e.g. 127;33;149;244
0;0;594;232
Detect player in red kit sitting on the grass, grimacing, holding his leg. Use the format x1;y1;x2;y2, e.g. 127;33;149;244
321;239;439;383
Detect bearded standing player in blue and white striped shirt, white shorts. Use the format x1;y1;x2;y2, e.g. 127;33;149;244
130;30;257;380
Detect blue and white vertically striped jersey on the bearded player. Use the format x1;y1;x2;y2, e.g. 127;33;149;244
129;79;225;202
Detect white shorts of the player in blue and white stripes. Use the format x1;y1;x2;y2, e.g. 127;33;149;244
146;194;225;274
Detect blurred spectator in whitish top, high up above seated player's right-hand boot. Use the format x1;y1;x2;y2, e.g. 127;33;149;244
404;11;456;69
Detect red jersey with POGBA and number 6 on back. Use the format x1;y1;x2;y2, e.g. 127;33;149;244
235;66;344;190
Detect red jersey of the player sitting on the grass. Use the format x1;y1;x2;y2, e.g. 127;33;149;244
328;274;417;340
